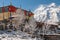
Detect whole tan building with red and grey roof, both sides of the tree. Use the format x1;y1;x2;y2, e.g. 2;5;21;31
0;5;34;20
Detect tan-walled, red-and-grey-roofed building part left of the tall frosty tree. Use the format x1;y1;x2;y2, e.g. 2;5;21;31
0;5;17;20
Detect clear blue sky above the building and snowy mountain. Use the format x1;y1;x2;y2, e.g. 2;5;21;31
0;0;60;11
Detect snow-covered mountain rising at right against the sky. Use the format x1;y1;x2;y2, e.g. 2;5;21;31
34;3;60;24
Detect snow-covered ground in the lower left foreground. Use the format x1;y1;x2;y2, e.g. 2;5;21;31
0;30;42;40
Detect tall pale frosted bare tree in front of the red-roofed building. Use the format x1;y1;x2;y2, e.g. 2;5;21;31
14;9;26;29
